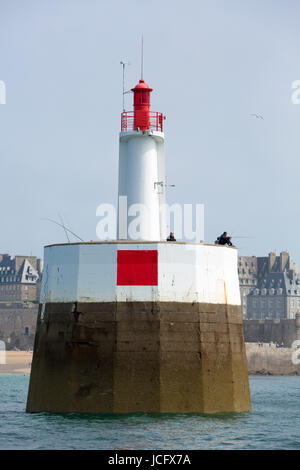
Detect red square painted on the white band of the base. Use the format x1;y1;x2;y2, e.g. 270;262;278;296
117;250;158;286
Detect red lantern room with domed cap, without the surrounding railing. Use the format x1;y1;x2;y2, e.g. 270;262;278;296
131;78;153;131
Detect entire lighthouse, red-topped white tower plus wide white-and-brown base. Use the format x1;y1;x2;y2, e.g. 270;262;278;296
26;69;251;413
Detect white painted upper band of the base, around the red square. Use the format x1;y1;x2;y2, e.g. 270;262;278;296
41;242;240;305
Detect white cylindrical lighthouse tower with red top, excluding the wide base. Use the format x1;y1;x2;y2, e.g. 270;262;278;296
118;79;166;241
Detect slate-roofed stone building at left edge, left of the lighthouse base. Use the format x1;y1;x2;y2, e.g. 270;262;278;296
0;254;42;302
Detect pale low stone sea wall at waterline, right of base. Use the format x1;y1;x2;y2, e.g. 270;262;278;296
246;343;300;375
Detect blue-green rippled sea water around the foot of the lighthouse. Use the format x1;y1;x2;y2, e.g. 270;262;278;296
0;375;300;450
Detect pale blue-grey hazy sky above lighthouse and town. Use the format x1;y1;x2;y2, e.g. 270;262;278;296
0;0;300;265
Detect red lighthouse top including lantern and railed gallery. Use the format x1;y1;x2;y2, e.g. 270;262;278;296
121;78;164;132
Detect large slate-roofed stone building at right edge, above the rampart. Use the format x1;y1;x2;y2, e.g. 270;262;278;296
245;251;300;319
